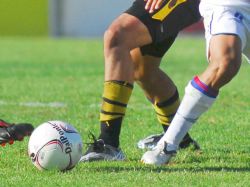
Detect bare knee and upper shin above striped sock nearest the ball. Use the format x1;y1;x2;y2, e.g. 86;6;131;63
104;13;152;83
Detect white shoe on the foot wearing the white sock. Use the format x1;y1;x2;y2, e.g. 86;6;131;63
141;142;176;166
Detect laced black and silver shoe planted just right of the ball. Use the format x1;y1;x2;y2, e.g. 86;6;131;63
80;135;125;162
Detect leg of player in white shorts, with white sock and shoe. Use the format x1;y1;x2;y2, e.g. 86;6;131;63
142;4;245;165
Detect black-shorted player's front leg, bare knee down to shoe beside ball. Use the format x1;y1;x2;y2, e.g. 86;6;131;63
81;13;152;161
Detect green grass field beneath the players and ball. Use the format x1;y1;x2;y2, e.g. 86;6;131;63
0;37;250;187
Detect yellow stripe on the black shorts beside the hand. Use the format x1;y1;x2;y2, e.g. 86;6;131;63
152;0;187;21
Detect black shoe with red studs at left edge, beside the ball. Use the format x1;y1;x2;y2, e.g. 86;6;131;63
0;119;34;146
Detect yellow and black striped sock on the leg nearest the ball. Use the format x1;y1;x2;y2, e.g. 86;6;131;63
99;81;133;147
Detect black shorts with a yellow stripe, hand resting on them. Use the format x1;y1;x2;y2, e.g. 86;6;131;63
125;0;201;57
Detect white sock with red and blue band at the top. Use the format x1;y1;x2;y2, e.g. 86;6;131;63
159;77;217;150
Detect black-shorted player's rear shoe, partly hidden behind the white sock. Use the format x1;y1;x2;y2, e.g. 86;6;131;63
137;133;200;150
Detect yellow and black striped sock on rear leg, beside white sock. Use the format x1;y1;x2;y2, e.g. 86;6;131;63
154;90;180;132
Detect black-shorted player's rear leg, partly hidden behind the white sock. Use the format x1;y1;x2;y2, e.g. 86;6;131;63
131;47;199;149
